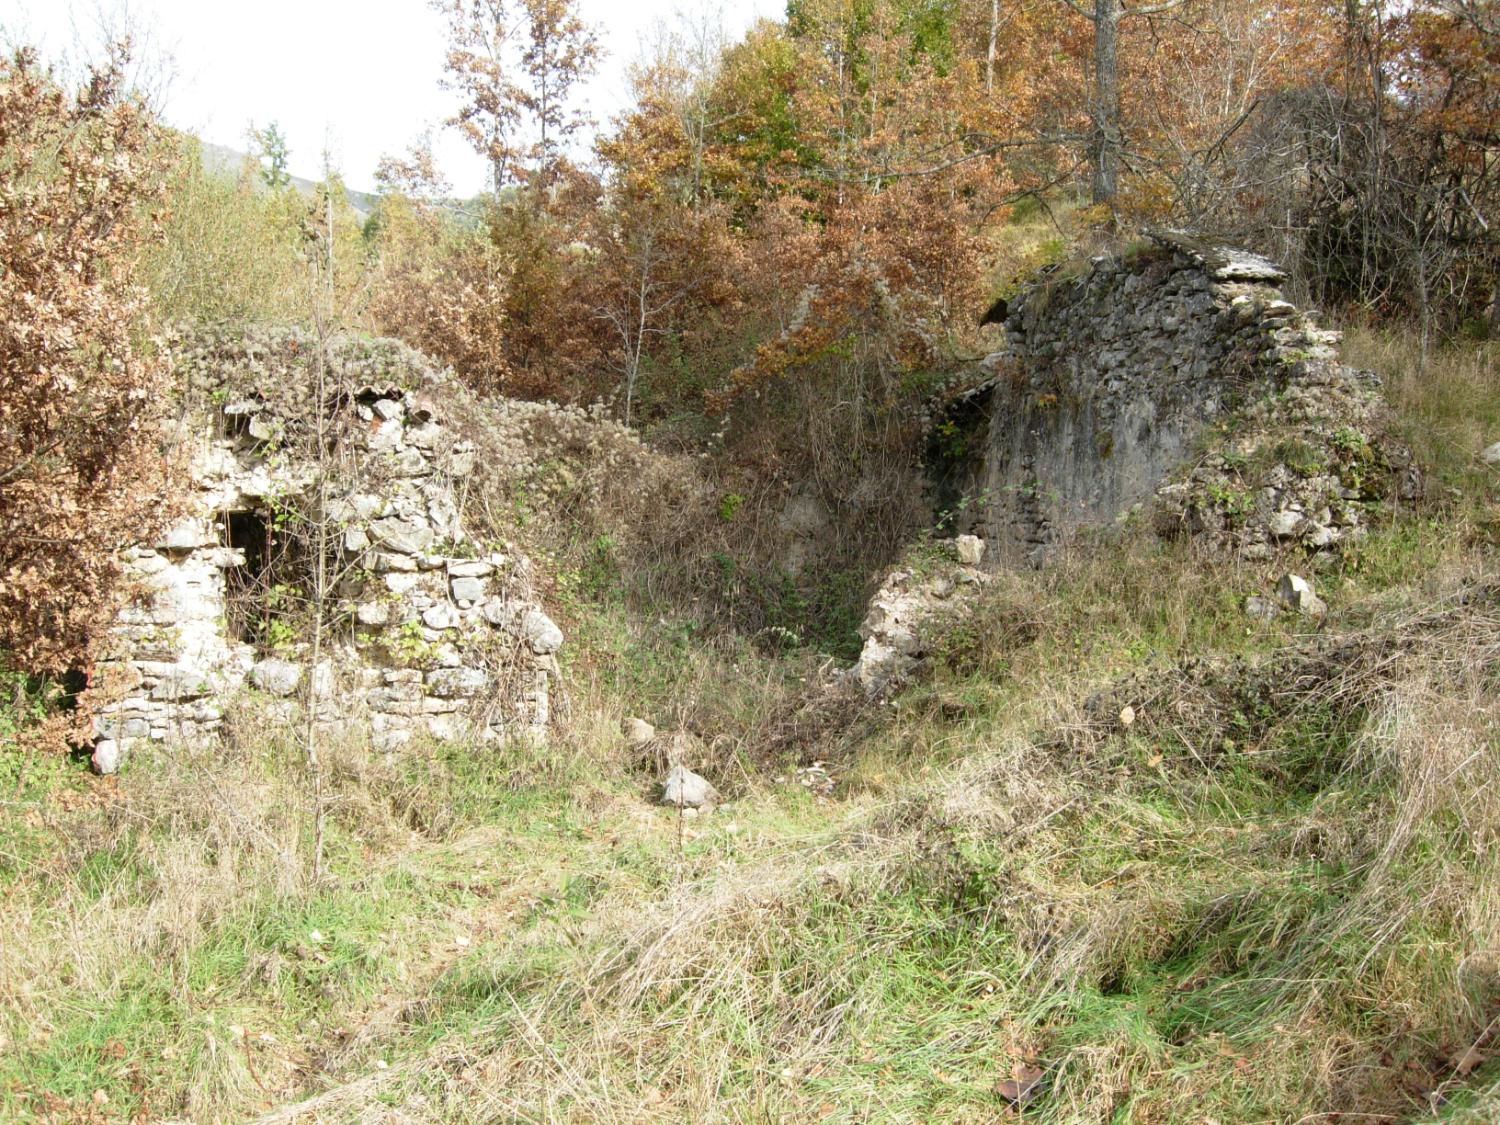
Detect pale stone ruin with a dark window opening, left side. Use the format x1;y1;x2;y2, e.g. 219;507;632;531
92;329;563;773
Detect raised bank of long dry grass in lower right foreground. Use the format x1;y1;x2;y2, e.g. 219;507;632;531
158;576;1500;1122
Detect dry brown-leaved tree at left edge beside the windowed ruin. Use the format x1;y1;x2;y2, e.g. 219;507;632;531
0;50;177;672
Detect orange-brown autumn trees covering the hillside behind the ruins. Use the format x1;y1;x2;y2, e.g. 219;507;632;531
384;0;1500;422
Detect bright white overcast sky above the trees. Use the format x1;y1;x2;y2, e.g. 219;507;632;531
0;0;785;195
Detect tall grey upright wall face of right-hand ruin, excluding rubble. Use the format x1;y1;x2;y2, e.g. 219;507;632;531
935;233;1364;563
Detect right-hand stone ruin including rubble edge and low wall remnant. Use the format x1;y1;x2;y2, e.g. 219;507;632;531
852;233;1424;696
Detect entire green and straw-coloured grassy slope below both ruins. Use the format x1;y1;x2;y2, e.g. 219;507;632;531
0;332;1500;1125
